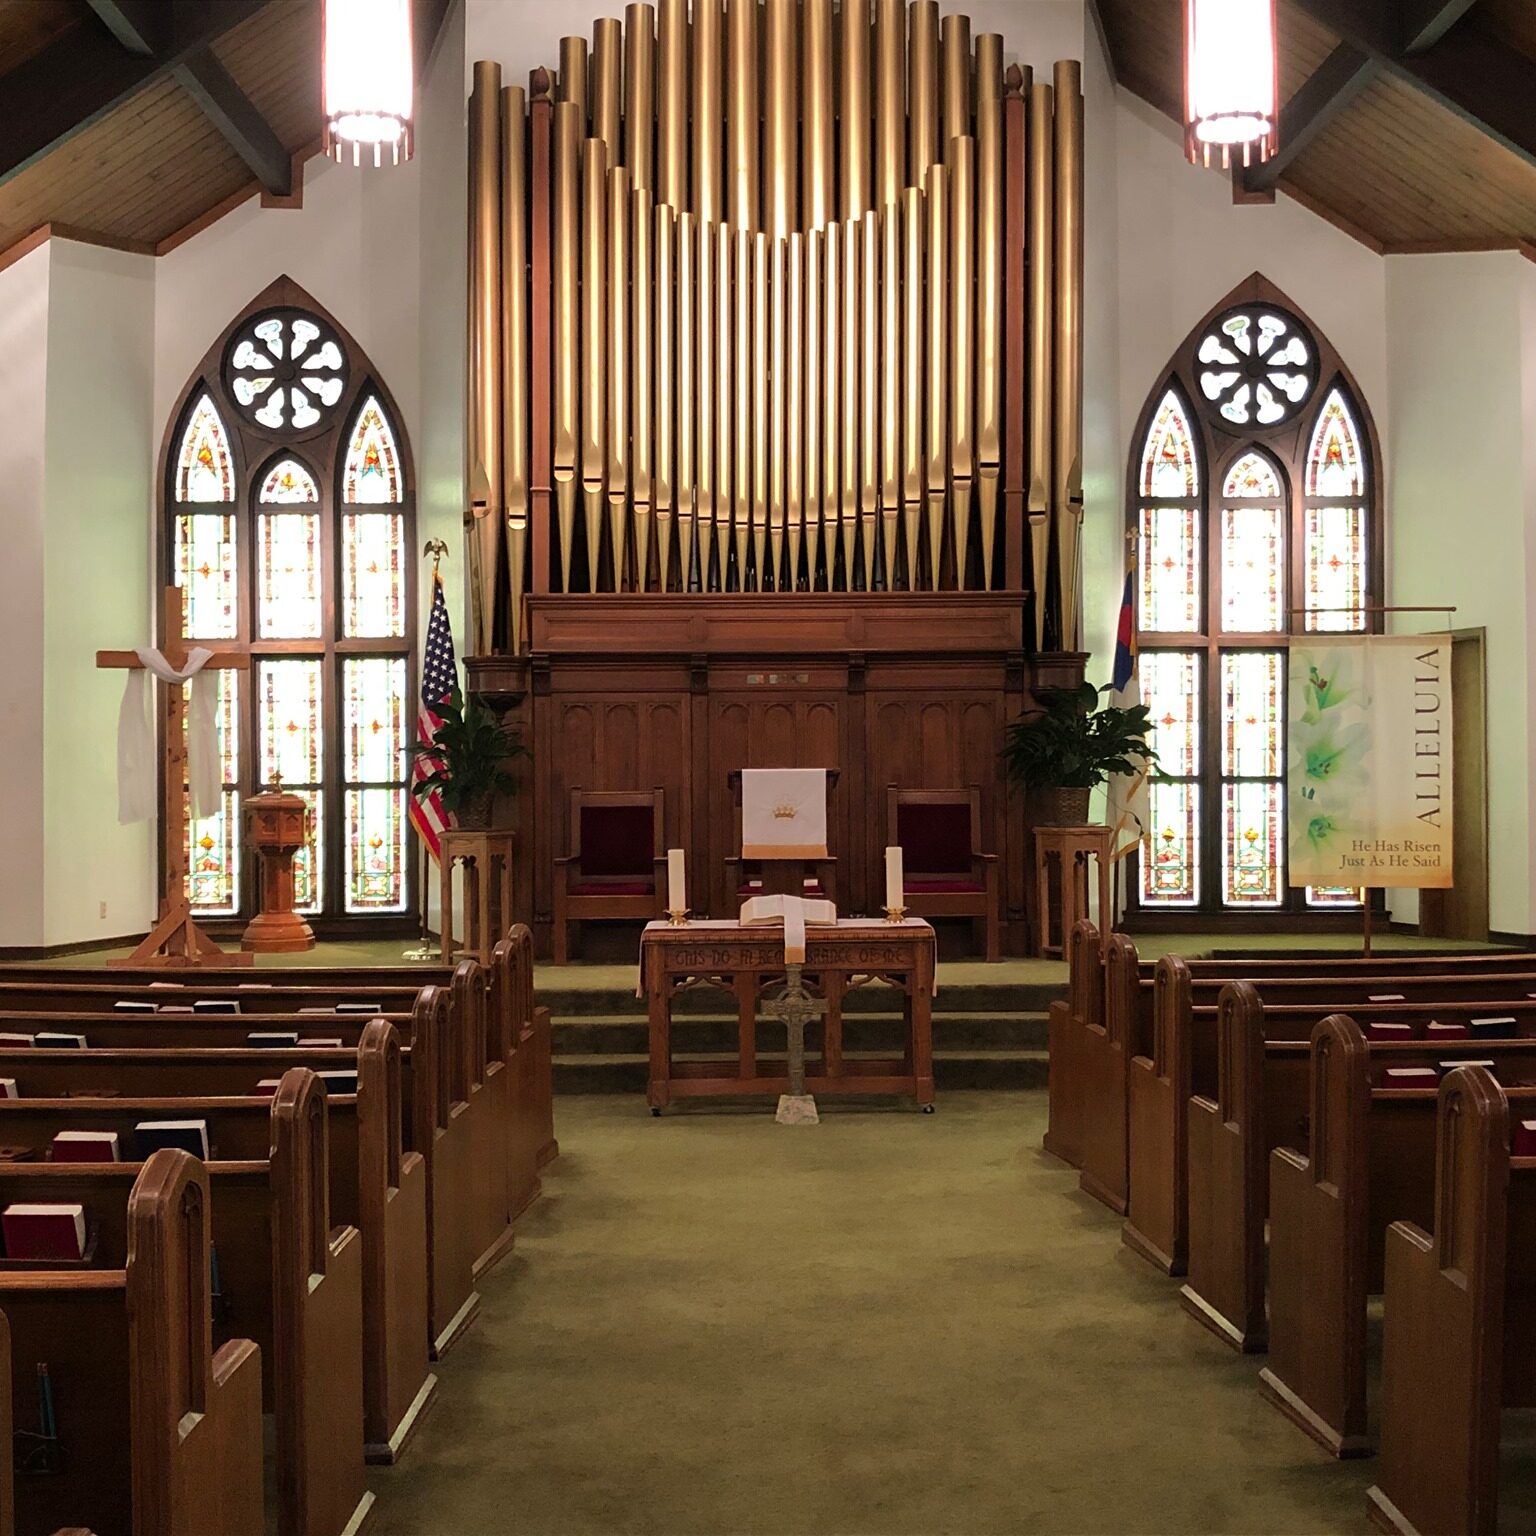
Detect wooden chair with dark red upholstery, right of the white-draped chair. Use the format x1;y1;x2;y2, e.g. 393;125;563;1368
886;783;998;960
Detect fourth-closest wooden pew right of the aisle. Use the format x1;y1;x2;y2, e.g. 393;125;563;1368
1130;976;1536;1275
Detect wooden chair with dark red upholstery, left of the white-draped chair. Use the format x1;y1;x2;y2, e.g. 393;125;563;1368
554;790;667;965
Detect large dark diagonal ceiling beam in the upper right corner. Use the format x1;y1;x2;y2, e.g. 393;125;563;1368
1292;0;1536;166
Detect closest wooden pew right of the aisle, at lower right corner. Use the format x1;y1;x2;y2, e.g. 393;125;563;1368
1367;1066;1536;1536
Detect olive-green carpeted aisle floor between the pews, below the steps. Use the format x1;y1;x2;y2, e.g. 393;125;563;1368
370;1092;1373;1536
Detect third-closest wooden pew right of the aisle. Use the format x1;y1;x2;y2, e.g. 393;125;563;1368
1183;982;1536;1353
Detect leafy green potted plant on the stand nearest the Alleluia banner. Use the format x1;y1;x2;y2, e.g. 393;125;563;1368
1003;682;1157;826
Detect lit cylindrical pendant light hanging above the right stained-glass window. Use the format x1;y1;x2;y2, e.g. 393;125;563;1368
1184;0;1279;169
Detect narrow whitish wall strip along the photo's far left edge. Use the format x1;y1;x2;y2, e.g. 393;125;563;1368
0;246;51;946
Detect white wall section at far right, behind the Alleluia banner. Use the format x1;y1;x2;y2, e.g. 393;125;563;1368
1384;252;1536;934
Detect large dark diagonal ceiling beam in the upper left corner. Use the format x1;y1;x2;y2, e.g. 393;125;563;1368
0;0;267;184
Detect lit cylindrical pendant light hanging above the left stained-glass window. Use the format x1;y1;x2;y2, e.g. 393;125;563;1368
321;0;416;166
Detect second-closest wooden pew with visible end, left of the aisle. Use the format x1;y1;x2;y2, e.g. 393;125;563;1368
0;1068;373;1536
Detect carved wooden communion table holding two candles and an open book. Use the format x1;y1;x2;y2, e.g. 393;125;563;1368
641;917;937;1115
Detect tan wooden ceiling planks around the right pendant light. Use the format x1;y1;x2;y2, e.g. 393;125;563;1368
1100;0;1536;252
